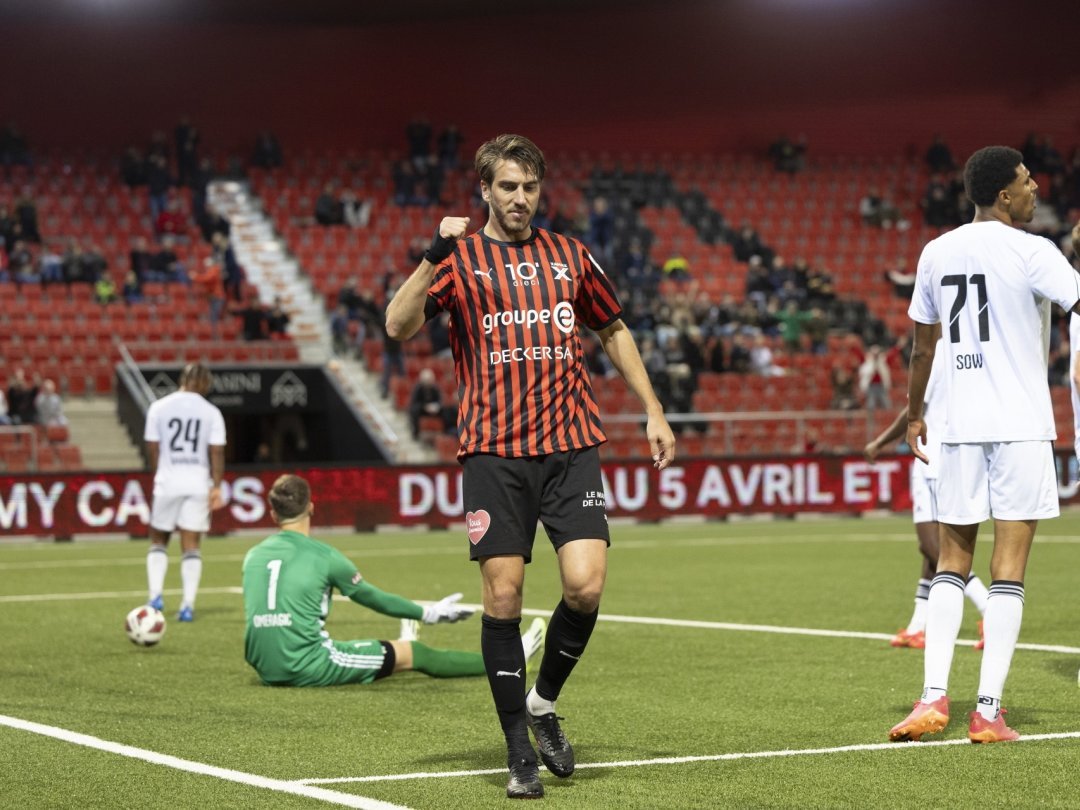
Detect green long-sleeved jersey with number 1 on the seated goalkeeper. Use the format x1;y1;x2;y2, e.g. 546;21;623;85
243;531;423;683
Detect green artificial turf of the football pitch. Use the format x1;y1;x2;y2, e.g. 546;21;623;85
0;515;1080;810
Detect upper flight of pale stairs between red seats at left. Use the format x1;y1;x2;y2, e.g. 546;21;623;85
207;180;330;364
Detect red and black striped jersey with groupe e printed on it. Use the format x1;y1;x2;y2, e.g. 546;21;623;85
426;228;622;458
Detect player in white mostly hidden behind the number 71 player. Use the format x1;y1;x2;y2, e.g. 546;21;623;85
863;338;987;649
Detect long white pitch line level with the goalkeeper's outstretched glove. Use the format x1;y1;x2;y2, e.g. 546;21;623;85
0;585;1080;656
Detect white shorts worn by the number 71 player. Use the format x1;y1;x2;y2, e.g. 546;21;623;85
937;442;1061;526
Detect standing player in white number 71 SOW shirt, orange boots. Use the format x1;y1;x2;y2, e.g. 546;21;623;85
889;147;1080;743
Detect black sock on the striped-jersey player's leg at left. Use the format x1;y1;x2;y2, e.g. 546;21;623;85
480;613;532;750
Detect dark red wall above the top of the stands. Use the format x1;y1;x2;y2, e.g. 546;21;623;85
0;0;1080;154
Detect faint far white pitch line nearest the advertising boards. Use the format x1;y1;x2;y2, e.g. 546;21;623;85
0;531;1080;571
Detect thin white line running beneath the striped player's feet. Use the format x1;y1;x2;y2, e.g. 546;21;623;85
296;731;1080;785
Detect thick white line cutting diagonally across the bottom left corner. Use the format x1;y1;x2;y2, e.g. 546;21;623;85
0;715;407;810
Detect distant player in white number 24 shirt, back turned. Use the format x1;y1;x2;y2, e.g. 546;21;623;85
143;363;225;622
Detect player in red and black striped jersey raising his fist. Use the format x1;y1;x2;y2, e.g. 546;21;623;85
387;135;675;798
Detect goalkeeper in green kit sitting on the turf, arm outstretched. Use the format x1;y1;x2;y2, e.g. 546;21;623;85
244;475;545;686
